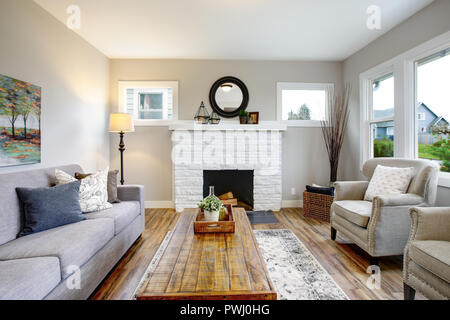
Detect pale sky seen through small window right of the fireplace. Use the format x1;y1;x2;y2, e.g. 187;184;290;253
282;90;326;120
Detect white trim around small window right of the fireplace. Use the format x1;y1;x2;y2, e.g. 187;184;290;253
277;82;334;128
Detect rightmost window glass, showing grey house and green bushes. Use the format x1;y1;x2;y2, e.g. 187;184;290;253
415;49;450;172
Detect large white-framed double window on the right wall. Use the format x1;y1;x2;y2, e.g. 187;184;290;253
360;31;450;187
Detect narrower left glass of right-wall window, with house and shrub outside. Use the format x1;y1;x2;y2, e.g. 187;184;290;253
370;73;394;158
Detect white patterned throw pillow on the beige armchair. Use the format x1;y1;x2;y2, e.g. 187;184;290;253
364;165;414;201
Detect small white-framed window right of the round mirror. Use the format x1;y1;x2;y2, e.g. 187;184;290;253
277;82;334;126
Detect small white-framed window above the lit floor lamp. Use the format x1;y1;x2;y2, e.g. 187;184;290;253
119;81;178;125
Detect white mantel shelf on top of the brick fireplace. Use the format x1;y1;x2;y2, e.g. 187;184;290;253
169;120;287;131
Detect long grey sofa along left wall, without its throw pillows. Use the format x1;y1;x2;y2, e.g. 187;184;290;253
0;165;145;300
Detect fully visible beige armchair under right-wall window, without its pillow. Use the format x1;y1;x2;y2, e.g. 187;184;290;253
331;158;439;264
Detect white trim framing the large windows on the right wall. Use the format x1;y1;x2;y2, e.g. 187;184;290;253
359;31;450;188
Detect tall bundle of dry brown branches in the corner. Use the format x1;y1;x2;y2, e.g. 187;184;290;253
321;84;351;185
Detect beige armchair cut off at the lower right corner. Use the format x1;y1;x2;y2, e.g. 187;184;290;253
403;208;450;300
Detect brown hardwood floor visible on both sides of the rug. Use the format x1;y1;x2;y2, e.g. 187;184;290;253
91;208;423;300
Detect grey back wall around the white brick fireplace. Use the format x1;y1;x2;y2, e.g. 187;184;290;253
110;60;342;201
